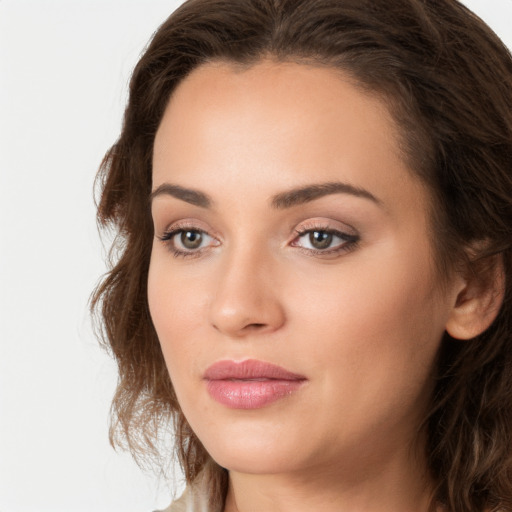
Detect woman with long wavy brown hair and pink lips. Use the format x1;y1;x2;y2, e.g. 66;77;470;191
93;0;512;512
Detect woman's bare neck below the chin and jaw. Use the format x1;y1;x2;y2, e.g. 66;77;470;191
225;436;432;512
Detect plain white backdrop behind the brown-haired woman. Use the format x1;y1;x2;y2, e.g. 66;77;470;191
0;0;512;512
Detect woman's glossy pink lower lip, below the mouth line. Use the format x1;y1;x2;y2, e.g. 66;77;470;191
207;379;304;409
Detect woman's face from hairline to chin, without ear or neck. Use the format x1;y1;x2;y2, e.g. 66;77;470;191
148;62;456;474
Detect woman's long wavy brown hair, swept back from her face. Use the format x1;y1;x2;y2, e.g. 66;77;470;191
92;0;512;512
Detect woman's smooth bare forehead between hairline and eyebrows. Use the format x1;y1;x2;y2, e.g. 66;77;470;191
153;61;428;216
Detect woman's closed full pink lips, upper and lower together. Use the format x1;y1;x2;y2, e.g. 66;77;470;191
204;359;306;409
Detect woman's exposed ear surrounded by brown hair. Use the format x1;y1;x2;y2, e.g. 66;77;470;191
446;254;505;340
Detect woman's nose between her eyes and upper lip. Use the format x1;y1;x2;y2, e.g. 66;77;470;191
210;246;285;338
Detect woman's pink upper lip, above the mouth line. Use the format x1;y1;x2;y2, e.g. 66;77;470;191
204;359;306;380
